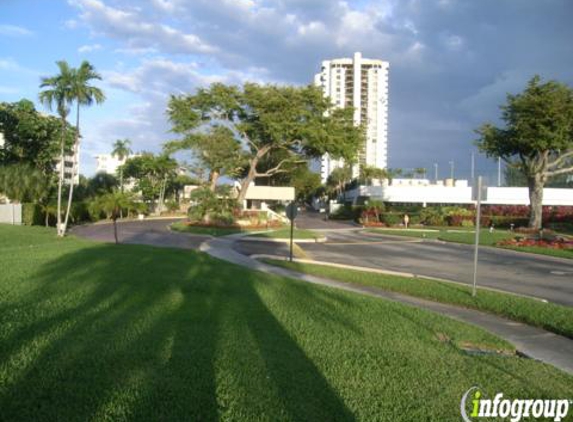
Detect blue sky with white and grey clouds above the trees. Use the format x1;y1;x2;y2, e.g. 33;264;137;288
0;0;573;180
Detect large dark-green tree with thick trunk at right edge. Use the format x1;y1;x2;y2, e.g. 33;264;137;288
476;76;573;229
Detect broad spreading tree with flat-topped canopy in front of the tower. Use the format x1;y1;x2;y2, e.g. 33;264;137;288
168;83;364;203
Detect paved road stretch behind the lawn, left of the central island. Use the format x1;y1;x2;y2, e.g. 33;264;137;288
72;219;210;249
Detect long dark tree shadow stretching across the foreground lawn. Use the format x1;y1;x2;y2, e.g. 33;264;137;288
0;245;354;421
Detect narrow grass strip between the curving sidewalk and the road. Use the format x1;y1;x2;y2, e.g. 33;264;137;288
264;259;573;339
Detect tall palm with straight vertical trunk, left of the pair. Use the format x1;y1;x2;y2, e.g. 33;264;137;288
39;60;74;237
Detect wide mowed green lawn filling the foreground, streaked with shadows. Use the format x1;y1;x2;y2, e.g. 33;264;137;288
0;225;573;422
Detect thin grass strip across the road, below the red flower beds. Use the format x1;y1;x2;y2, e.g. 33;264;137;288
366;228;573;259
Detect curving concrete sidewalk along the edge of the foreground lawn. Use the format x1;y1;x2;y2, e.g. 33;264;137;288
200;234;573;374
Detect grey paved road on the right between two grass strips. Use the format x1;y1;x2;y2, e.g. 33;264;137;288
301;232;573;306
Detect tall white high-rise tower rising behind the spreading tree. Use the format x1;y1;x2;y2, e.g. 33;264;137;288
314;53;389;183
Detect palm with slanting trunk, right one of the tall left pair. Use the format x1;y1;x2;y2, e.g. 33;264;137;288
63;60;105;234
